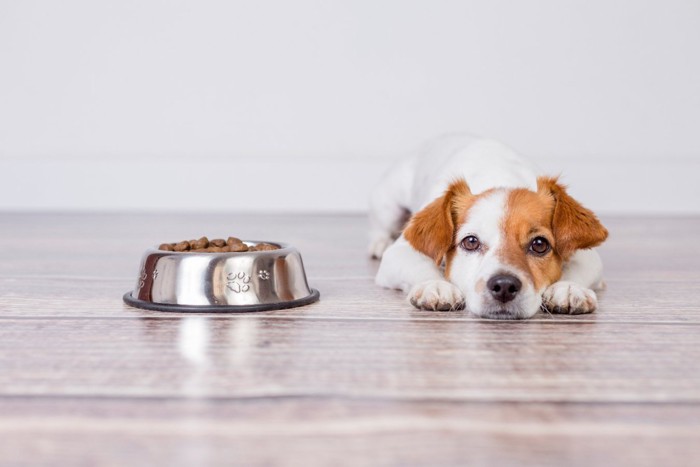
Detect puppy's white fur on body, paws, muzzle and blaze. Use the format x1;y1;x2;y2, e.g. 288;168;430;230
369;134;602;319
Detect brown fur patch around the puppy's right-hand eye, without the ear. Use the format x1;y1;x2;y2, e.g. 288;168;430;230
500;189;562;291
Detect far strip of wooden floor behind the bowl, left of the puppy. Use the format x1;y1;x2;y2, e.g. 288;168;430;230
0;214;376;278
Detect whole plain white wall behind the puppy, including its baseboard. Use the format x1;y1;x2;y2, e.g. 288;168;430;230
0;0;700;213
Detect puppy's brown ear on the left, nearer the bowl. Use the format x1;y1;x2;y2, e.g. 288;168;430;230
403;179;472;266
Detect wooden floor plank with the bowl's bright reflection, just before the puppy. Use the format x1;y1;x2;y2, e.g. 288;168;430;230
0;316;700;403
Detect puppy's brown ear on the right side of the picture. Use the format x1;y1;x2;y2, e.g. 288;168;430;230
537;177;608;260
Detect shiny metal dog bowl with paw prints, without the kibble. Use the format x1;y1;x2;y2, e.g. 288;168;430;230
124;241;319;313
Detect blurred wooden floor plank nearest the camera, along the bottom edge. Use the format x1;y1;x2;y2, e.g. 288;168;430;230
0;398;700;466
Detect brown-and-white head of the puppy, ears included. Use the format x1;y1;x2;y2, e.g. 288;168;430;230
404;178;608;319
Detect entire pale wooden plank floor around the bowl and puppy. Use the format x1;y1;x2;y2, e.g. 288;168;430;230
0;213;700;467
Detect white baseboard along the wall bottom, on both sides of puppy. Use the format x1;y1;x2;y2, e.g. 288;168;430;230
0;158;700;214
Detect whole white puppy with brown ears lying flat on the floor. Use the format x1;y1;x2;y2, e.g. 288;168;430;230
369;134;608;319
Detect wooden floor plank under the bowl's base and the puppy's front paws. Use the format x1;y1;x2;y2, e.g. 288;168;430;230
0;276;700;324
